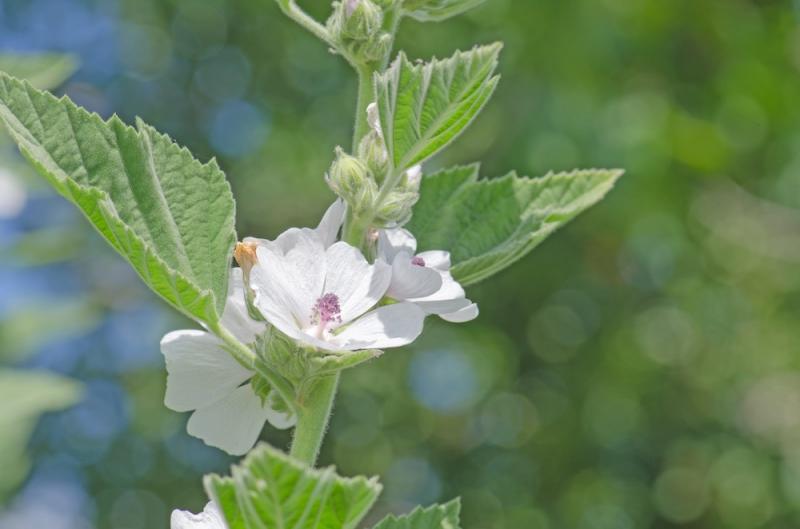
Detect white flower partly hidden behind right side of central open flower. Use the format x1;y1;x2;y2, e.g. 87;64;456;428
378;228;478;323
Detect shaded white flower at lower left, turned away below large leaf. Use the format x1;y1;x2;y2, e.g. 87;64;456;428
161;268;295;455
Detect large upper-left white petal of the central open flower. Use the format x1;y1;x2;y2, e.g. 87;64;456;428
250;228;325;330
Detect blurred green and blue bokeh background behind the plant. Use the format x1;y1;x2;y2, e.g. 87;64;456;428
0;0;800;529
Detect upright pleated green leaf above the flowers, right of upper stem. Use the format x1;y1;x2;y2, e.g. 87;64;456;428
375;43;502;172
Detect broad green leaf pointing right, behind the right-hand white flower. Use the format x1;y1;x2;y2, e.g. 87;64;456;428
407;165;623;285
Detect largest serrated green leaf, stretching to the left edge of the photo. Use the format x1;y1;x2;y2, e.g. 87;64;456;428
0;74;236;328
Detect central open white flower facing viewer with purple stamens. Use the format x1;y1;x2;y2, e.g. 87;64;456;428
250;227;425;351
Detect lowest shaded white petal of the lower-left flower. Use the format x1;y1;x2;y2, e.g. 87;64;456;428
187;384;272;456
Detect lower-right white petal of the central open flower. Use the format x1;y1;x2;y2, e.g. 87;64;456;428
336;303;425;350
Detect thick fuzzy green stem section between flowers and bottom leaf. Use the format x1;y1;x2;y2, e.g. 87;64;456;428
289;373;339;467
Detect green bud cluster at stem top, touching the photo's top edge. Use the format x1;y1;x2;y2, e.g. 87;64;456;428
328;0;393;64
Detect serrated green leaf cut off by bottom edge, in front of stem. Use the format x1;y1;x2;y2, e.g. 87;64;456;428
205;444;381;529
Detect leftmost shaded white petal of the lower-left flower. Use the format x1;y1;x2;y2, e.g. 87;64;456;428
161;331;253;411
